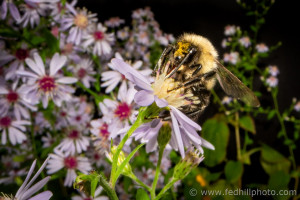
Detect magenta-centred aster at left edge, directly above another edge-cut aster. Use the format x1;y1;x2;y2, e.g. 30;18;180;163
0;84;37;120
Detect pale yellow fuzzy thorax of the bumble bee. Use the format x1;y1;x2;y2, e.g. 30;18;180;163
178;33;218;73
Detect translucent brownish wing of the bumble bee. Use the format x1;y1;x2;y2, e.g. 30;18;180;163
216;61;260;107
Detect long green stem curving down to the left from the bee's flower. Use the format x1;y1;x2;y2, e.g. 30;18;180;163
109;107;145;188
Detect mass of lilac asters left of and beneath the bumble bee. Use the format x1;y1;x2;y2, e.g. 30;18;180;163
0;0;209;199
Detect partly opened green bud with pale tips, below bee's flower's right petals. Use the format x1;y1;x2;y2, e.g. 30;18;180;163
173;147;204;180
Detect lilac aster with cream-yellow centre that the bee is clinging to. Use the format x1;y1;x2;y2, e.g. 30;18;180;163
112;59;214;157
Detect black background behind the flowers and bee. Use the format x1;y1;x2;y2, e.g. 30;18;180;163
77;0;300;183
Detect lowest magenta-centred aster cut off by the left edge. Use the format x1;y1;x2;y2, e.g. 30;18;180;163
0;115;30;145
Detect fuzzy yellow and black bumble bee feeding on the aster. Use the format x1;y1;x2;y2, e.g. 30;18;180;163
155;33;260;118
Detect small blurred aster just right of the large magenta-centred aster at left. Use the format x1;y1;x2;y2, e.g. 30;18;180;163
73;59;96;88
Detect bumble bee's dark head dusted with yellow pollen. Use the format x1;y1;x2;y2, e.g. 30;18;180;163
174;41;195;64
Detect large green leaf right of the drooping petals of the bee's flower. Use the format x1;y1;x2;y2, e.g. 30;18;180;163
202;118;229;167
